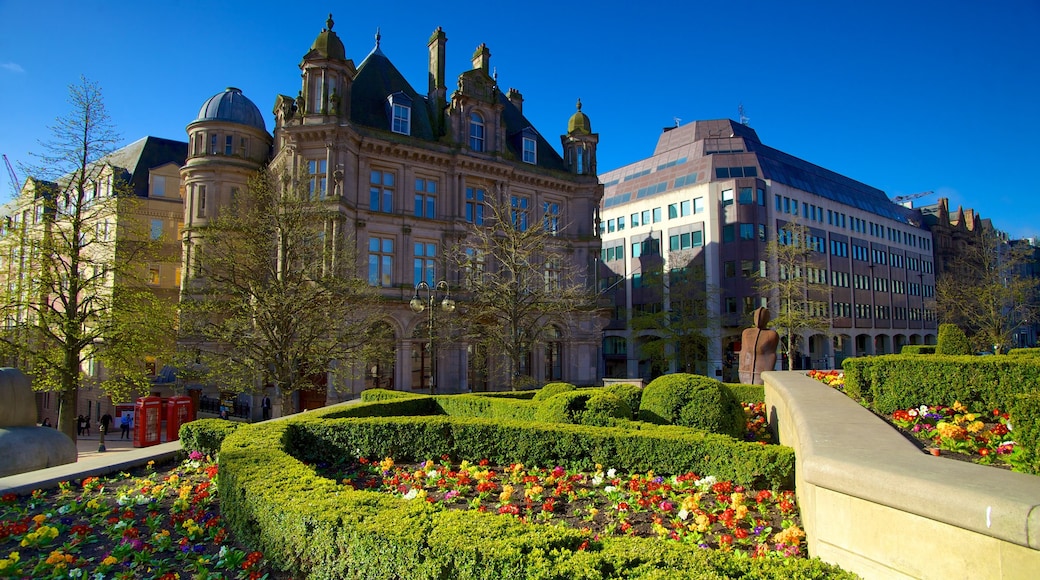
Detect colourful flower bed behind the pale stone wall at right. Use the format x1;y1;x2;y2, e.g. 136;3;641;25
808;370;1017;467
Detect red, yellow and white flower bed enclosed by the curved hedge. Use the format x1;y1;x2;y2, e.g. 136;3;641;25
317;457;804;556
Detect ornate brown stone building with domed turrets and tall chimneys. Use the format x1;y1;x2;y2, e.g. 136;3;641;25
182;16;602;407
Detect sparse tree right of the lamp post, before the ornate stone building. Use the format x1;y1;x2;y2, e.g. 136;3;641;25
449;192;595;389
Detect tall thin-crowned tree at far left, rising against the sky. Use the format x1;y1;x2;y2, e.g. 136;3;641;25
0;78;176;440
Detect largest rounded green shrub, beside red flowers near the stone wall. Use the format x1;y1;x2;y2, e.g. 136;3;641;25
640;373;747;439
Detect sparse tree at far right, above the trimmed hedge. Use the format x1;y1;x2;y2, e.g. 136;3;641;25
935;230;1040;351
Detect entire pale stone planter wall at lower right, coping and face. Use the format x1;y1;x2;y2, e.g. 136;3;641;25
762;371;1040;579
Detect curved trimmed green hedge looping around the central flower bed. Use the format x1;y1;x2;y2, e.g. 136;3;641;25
213;405;827;580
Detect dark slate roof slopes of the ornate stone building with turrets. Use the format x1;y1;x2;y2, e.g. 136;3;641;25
350;46;567;172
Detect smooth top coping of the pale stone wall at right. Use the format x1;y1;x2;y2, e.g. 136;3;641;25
762;371;1040;550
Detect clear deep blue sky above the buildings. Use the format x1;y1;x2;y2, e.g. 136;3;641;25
0;0;1040;237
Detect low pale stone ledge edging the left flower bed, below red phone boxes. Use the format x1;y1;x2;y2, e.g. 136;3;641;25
0;431;181;494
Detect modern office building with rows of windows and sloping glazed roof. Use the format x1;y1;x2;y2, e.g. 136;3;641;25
599;120;936;380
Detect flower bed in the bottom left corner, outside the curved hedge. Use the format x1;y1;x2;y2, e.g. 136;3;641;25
0;457;289;580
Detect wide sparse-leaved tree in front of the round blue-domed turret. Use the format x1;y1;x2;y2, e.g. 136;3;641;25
180;169;392;413
